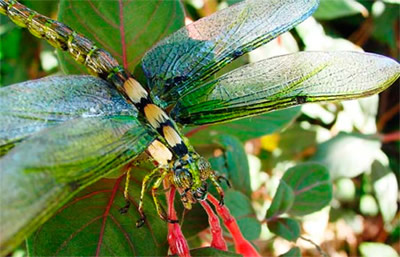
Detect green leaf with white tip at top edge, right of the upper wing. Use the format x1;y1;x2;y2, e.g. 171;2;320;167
313;0;368;20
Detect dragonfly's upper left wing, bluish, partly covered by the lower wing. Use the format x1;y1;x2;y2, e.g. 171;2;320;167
0;76;137;156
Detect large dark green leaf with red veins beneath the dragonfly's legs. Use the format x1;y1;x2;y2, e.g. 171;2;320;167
28;169;168;256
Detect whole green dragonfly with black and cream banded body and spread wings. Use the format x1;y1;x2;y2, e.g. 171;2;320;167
0;0;400;252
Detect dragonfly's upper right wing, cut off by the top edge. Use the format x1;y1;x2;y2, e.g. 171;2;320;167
142;0;318;107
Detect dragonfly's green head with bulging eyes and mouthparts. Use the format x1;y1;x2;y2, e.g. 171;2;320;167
173;153;212;209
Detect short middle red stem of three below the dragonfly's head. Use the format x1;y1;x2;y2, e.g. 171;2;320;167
200;201;228;251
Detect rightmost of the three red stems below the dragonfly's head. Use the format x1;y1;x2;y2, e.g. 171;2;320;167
207;194;261;257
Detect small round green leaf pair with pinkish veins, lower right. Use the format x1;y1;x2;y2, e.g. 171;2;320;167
266;163;332;241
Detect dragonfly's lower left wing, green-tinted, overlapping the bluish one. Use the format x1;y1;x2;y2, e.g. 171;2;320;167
0;116;154;254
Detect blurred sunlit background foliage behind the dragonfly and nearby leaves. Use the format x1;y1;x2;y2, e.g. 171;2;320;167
0;0;400;257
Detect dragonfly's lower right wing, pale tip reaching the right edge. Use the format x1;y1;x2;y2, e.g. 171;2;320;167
171;52;400;125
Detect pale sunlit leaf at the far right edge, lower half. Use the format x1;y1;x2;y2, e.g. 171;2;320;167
371;161;399;223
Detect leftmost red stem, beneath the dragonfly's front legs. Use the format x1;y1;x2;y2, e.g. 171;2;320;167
167;187;190;257
